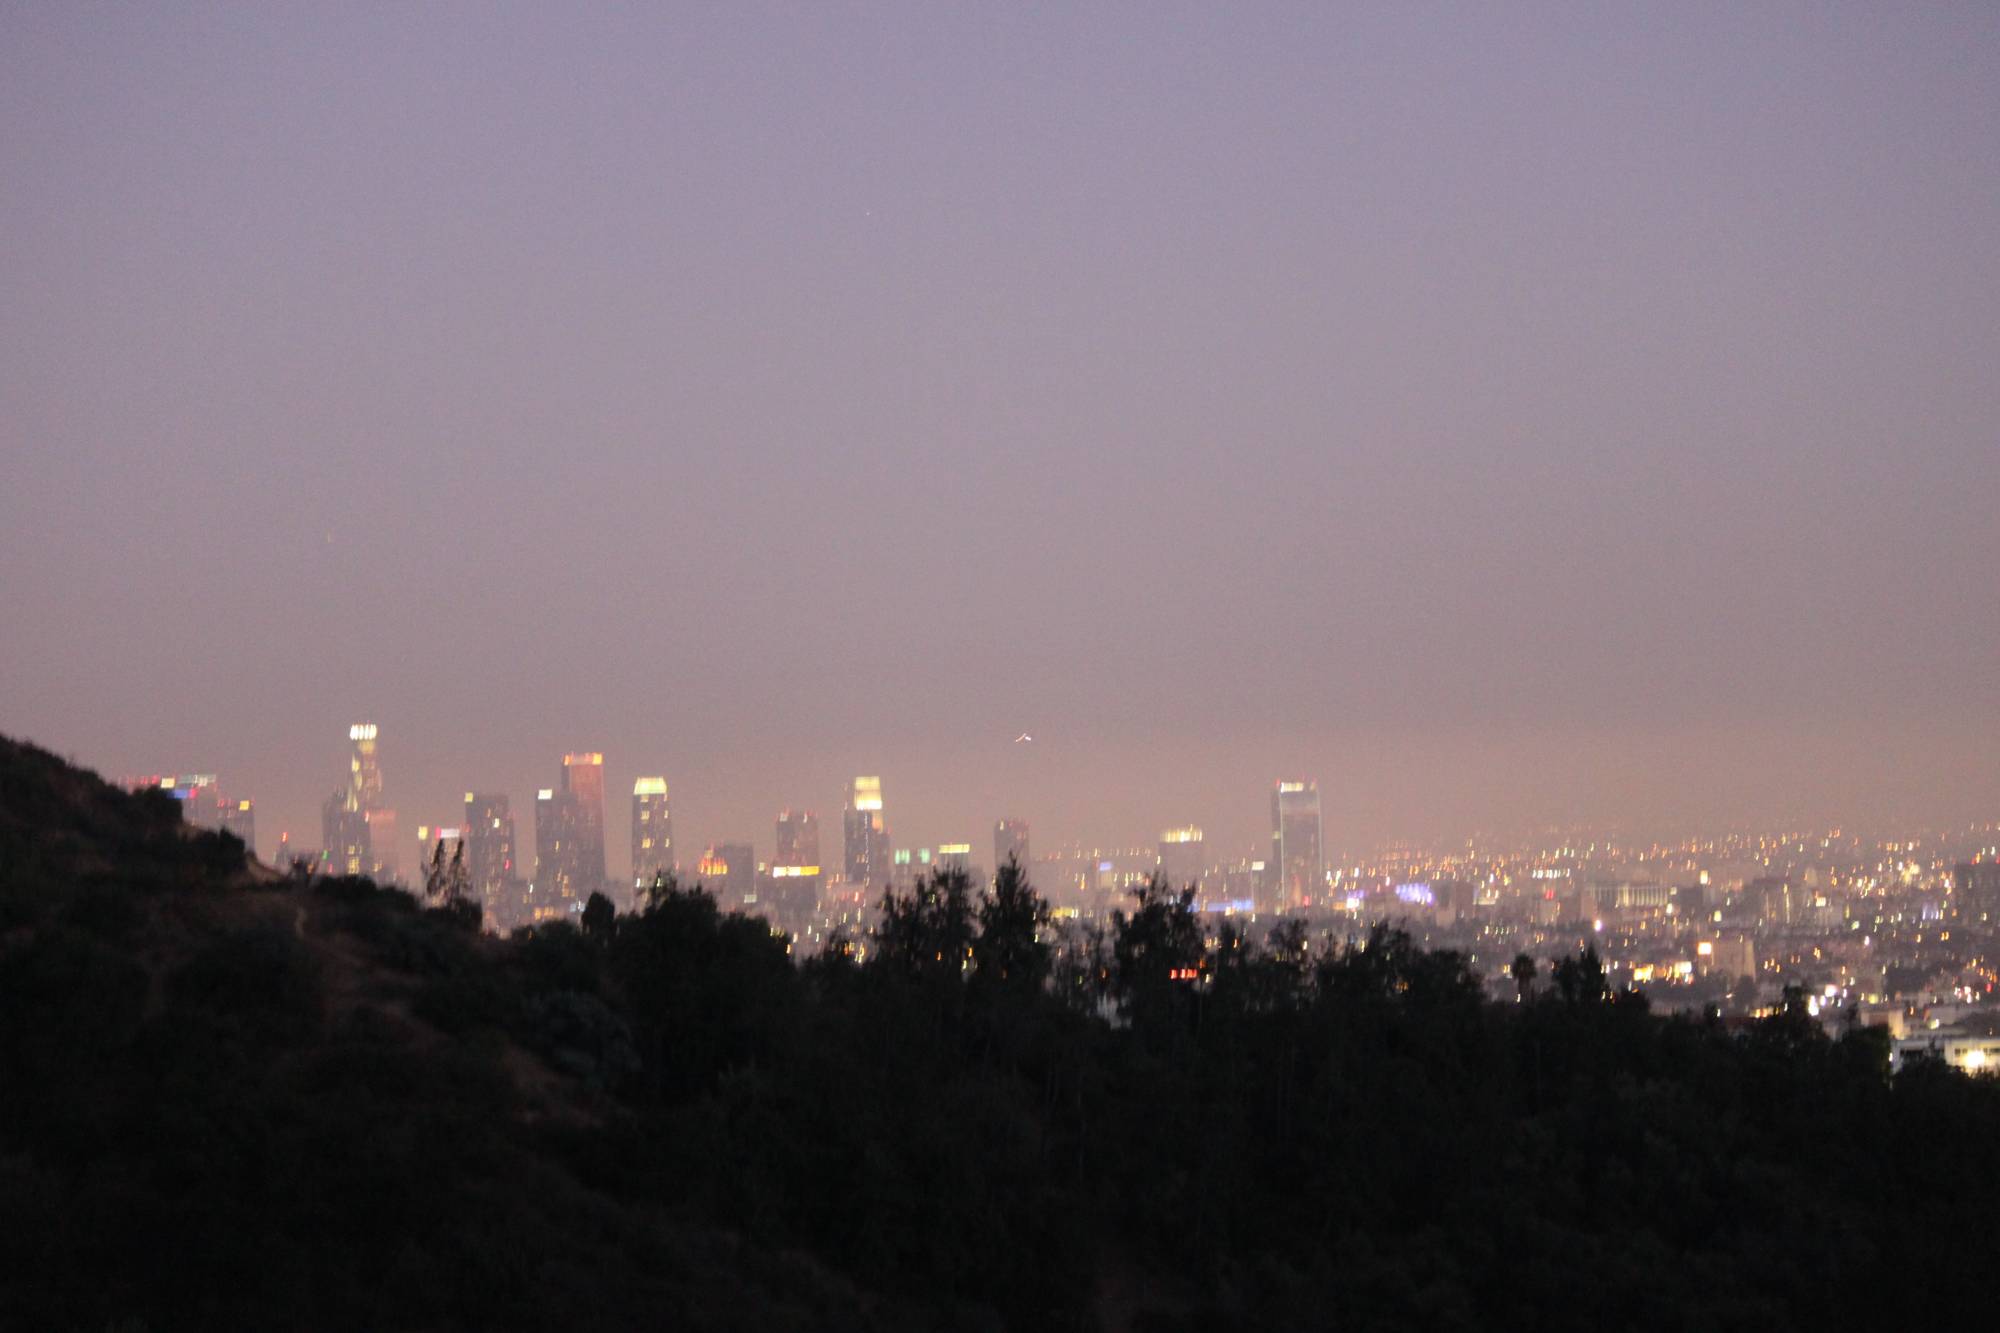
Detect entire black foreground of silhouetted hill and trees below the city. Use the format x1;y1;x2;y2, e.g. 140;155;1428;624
0;745;2000;1331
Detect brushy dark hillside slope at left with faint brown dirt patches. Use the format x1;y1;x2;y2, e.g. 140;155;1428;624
0;739;916;1331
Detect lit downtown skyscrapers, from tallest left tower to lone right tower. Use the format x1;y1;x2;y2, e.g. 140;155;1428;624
314;723;1326;937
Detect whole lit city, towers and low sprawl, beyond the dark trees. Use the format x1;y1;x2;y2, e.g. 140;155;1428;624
126;723;2000;1069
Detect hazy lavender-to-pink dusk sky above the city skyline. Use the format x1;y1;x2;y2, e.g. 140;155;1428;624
0;2;2000;871
